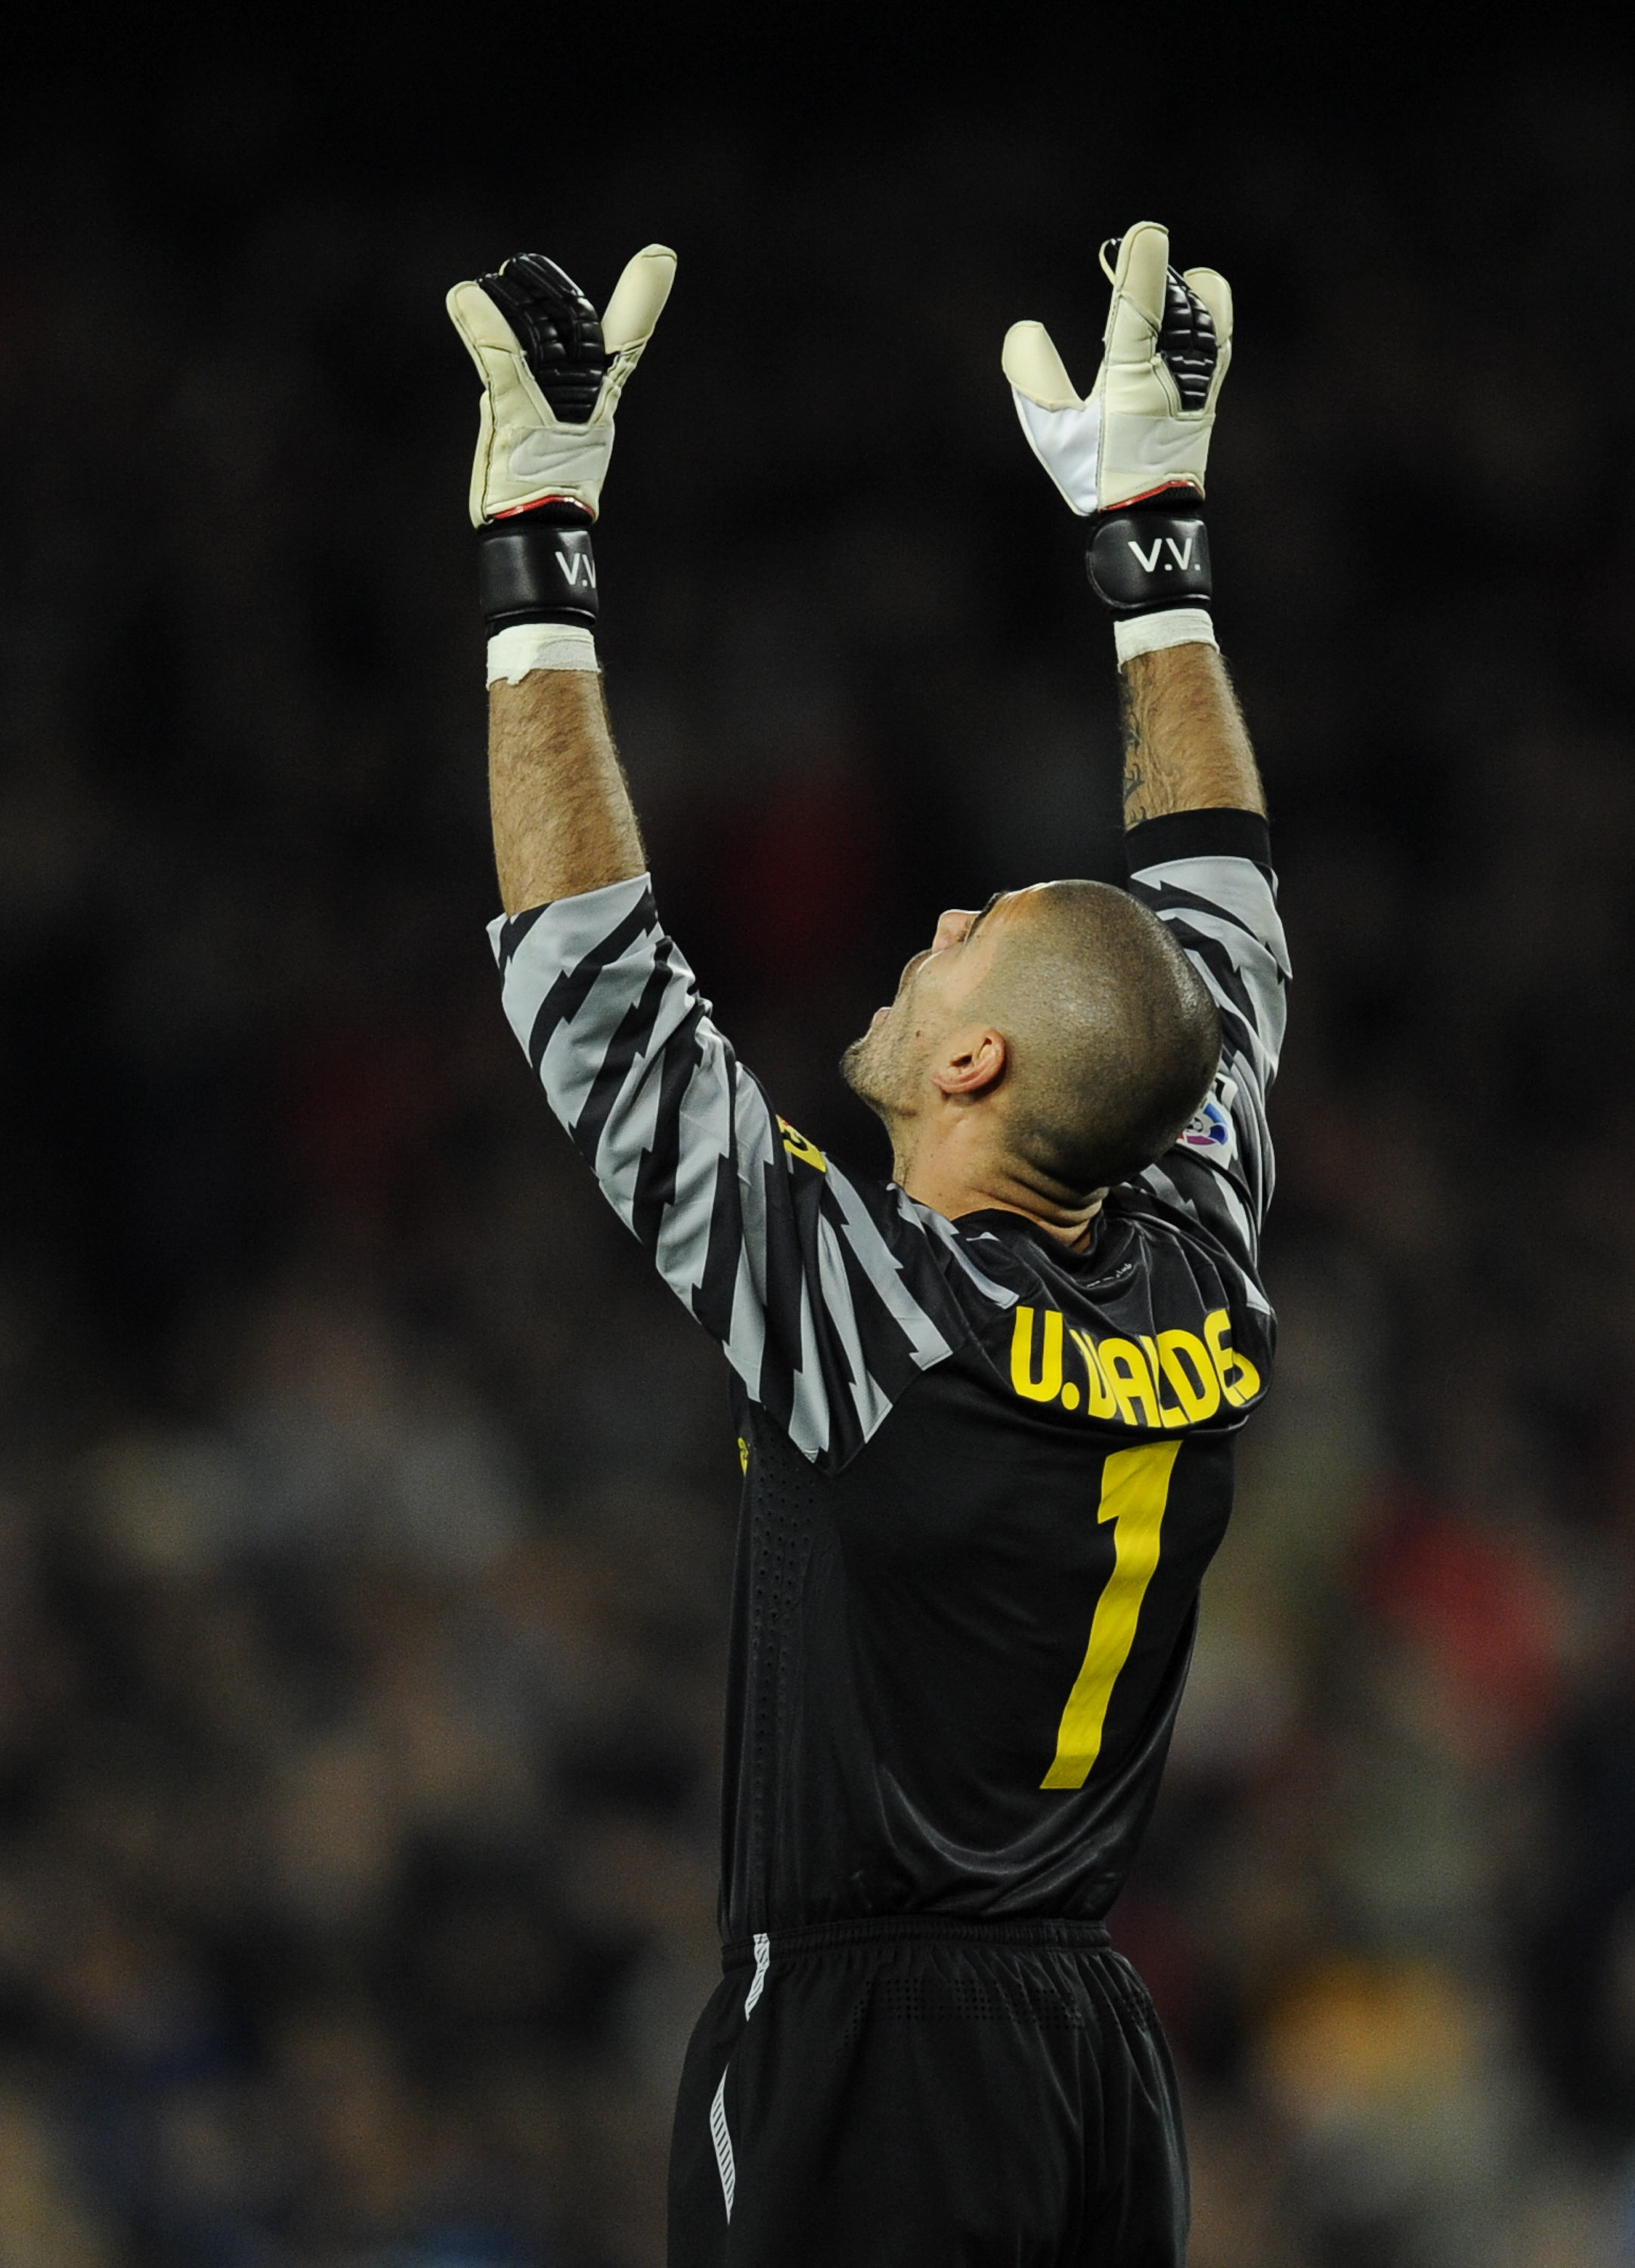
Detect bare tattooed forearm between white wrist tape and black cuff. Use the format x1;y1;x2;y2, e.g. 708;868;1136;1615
1120;646;1265;828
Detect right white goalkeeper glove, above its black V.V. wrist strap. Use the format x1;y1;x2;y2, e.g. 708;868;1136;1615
1002;220;1231;517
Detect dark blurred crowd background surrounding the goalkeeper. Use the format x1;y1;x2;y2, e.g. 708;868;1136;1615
0;7;1635;2268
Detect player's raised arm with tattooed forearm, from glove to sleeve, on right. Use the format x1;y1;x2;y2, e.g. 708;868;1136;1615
1005;220;1288;1270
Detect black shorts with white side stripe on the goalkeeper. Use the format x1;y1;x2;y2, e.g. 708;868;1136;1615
669;1919;1188;2268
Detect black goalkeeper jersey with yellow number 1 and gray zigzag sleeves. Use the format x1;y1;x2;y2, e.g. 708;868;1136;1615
492;812;1288;1939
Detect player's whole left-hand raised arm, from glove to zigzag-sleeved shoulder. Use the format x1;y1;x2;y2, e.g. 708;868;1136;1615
449;245;975;1465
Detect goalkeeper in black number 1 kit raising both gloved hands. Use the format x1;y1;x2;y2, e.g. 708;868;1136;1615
449;222;1286;2268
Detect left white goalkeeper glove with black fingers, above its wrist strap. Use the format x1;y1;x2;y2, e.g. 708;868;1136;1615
449;245;676;528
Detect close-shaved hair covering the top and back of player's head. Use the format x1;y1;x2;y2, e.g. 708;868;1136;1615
973;882;1220;1191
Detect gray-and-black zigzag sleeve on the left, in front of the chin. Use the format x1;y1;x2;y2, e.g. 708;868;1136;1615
490;878;971;1470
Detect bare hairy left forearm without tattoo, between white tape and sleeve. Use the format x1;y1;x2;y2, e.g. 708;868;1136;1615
488;669;646;914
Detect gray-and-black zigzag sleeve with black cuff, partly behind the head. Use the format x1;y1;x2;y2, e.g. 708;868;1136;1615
1129;848;1288;1270
